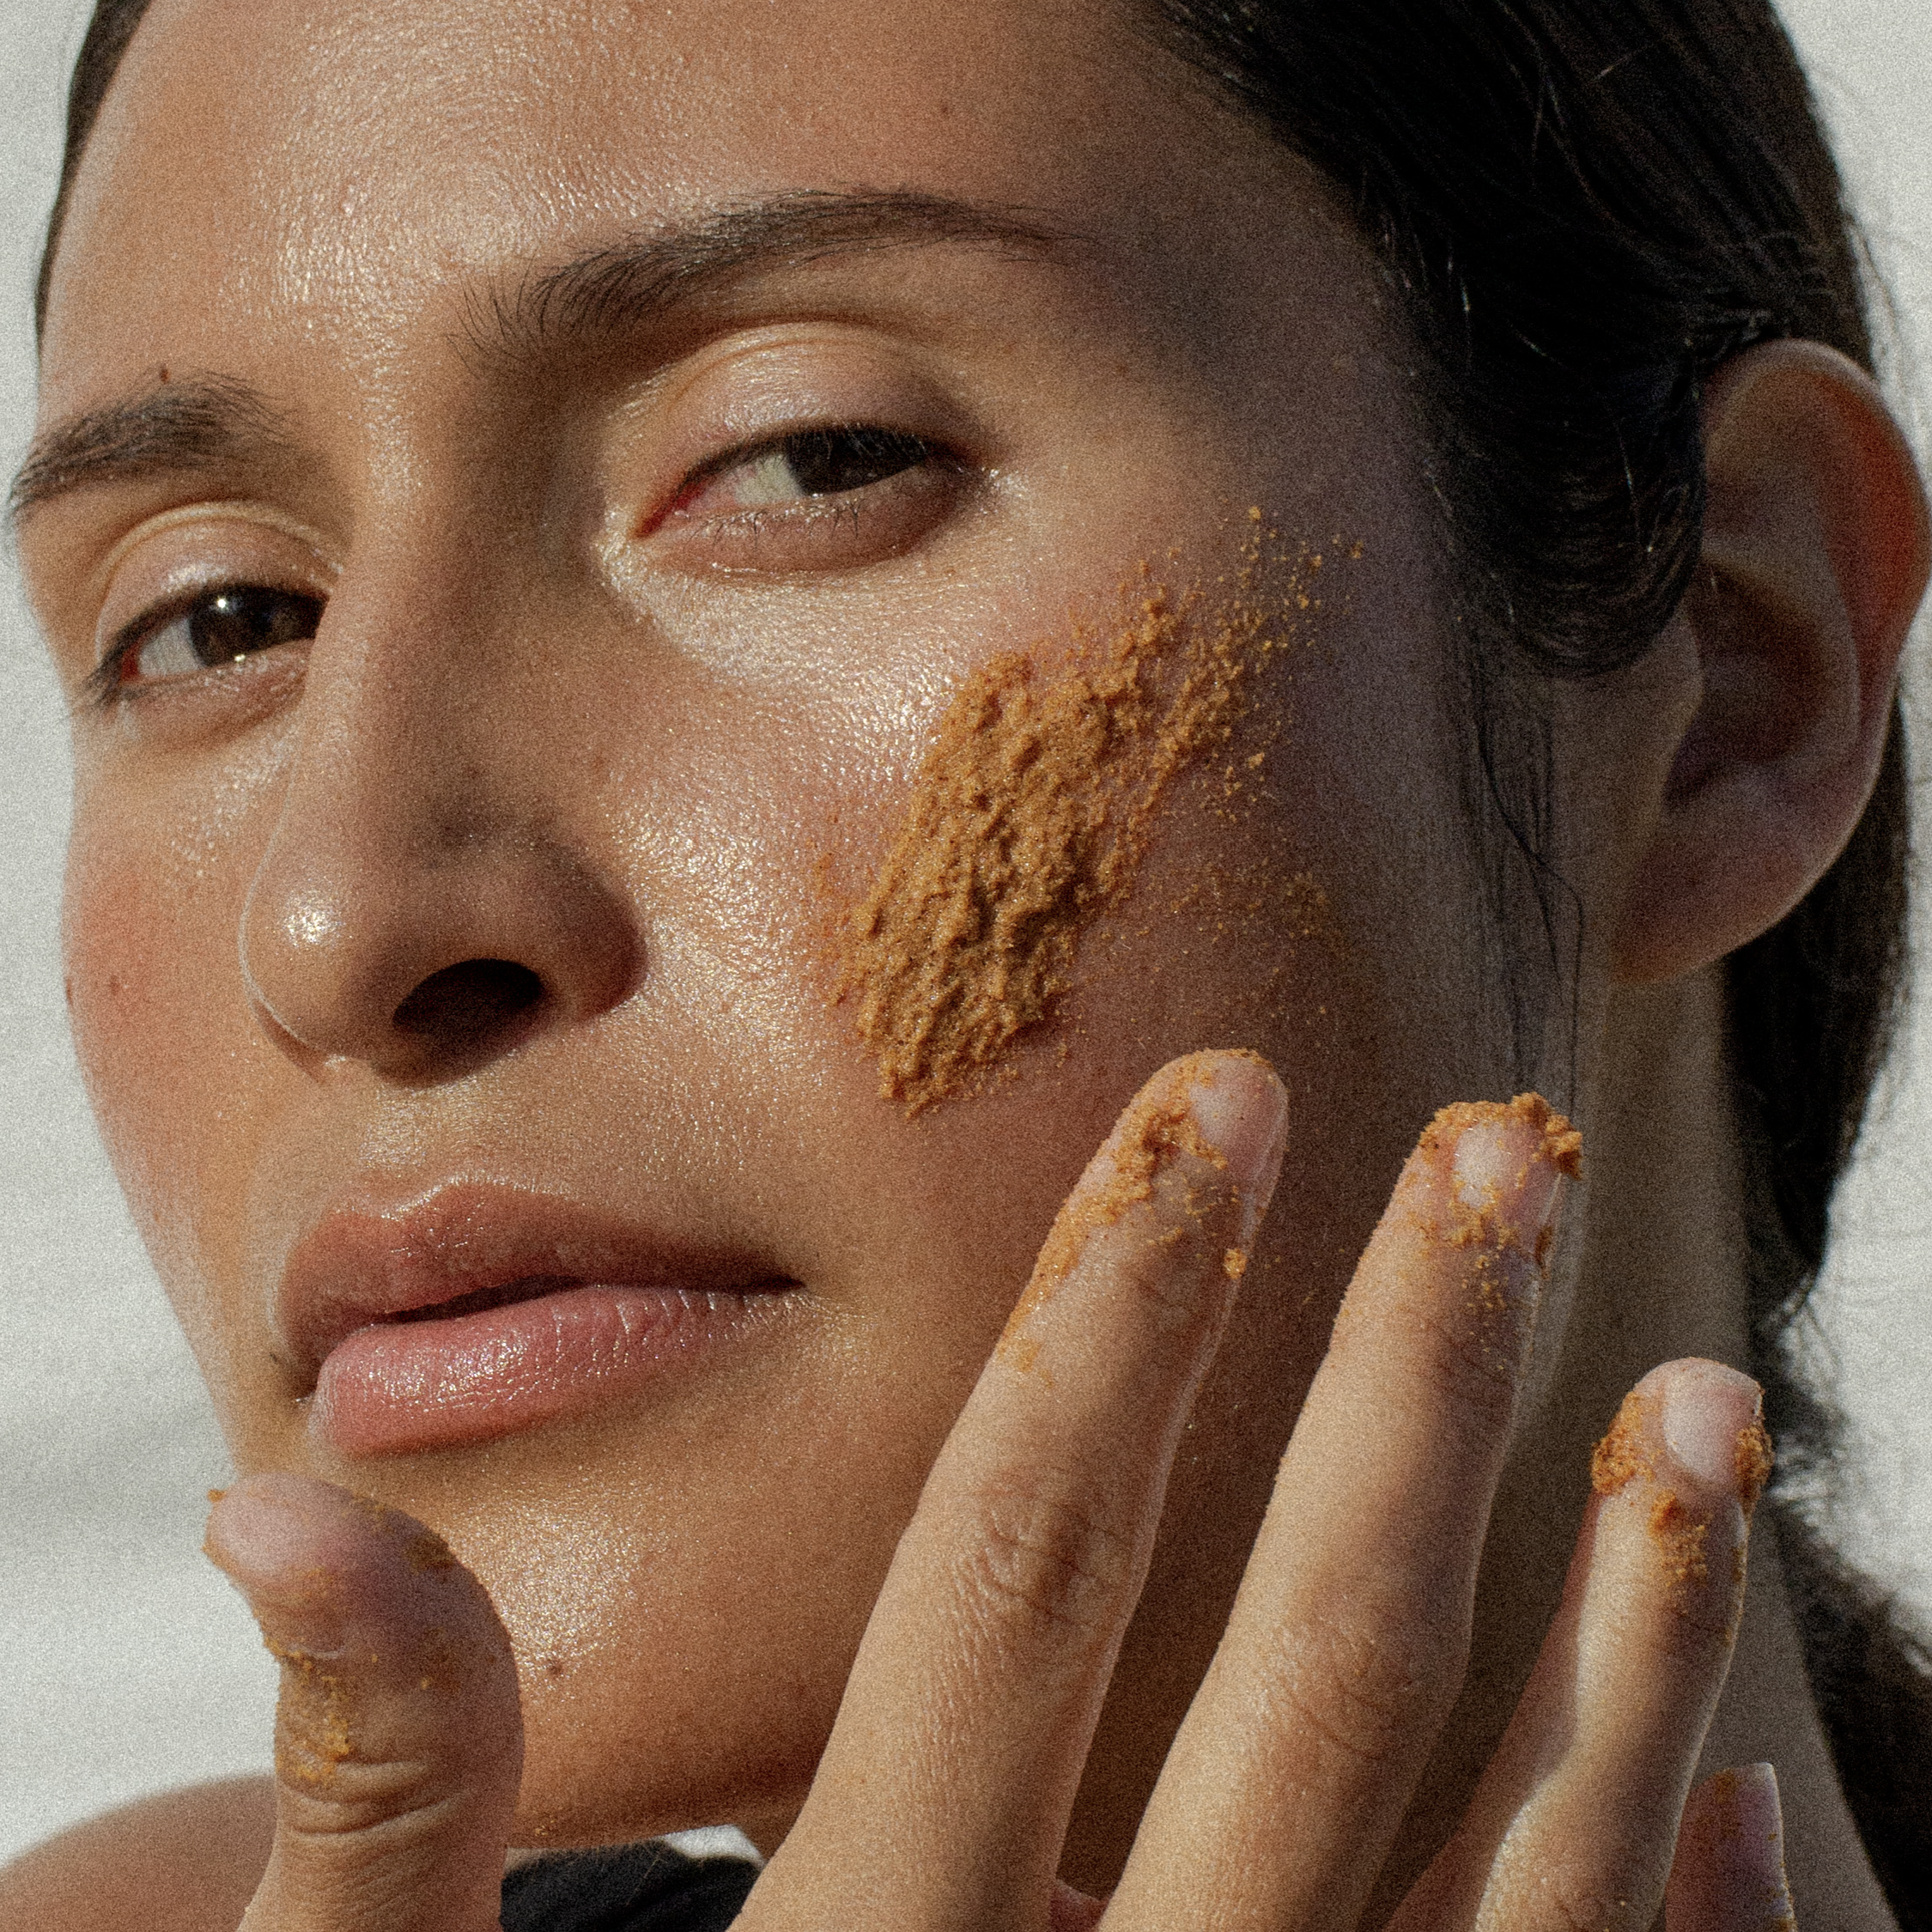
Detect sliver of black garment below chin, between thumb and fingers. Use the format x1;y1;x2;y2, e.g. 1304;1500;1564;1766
502;1839;757;1932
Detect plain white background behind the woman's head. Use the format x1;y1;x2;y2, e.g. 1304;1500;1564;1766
0;0;1932;1859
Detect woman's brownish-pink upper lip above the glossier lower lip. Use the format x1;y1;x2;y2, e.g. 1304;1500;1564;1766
275;1181;798;1385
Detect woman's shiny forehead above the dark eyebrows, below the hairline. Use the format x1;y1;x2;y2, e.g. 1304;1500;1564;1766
43;0;1306;392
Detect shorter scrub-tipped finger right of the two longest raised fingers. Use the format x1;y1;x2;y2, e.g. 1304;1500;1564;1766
1391;1362;1770;1932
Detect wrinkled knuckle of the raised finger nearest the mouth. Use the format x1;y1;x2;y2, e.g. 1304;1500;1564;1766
963;1474;1136;1637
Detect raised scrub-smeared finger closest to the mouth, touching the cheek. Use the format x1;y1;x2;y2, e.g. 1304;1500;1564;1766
742;1053;1287;1932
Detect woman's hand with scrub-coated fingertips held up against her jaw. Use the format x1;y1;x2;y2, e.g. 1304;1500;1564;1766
209;1053;1791;1932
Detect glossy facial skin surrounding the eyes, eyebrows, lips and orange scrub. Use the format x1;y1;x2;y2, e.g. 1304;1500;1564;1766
33;6;1476;1838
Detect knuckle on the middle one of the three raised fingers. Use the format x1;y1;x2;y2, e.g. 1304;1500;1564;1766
1272;1619;1468;1766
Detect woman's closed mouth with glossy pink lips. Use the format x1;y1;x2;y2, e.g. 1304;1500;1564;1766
275;1182;802;1457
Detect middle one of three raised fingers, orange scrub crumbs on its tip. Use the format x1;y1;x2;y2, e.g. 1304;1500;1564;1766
1107;1096;1577;1932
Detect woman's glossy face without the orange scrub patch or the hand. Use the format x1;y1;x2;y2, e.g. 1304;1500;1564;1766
21;0;1507;1841
